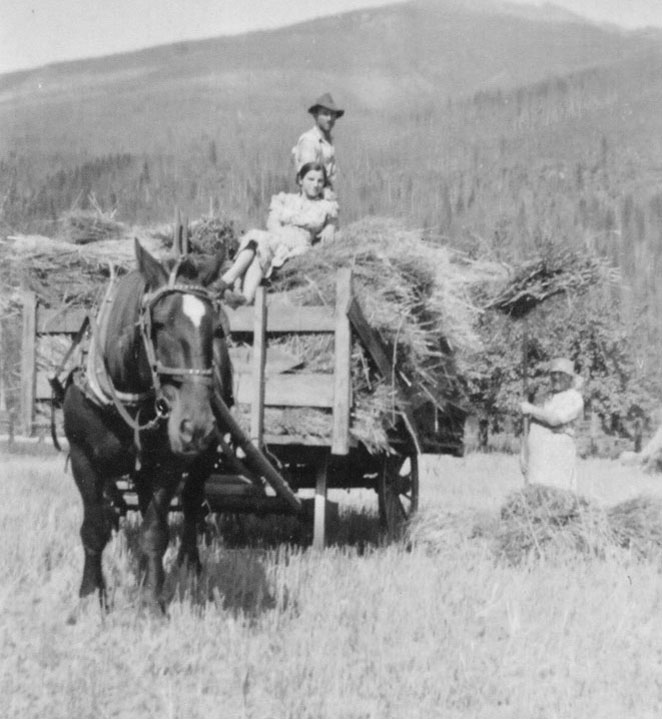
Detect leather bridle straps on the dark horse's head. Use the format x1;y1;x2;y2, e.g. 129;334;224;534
138;276;214;419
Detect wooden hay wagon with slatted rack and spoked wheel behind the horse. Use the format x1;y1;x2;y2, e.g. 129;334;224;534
23;245;464;546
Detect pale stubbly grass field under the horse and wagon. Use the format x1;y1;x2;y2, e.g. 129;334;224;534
0;454;662;719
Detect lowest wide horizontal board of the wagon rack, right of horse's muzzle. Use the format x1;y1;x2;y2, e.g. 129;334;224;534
235;373;333;409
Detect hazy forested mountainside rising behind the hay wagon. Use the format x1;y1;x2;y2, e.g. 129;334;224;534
0;1;662;428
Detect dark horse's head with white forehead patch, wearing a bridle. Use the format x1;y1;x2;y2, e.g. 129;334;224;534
136;241;222;458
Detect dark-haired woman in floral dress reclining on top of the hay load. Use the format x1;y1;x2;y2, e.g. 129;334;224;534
220;162;338;304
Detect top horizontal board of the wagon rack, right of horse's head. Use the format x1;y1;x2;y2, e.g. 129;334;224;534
224;302;335;334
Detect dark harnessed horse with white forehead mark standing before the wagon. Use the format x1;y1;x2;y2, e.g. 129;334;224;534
63;240;232;621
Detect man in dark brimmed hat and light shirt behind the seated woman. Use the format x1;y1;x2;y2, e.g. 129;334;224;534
292;92;345;200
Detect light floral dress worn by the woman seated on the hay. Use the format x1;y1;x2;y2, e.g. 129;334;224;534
240;192;338;277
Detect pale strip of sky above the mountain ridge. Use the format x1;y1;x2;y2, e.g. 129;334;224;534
0;0;662;73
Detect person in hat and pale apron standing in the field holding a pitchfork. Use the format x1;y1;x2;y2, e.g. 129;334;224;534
520;358;584;492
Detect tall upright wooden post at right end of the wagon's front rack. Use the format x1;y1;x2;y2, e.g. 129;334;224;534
331;268;352;454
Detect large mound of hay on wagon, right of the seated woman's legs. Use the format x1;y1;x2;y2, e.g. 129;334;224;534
274;218;502;362
